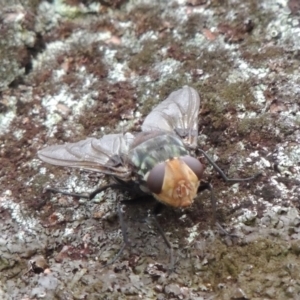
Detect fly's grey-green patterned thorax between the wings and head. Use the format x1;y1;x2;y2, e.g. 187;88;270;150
128;131;188;177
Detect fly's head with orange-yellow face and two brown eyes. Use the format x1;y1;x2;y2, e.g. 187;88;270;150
147;156;203;207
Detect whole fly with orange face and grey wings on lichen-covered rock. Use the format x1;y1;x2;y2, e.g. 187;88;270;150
38;86;260;267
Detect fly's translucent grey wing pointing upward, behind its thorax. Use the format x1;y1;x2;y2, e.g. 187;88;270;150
142;86;200;147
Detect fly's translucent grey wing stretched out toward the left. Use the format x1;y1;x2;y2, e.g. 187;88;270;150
38;133;134;179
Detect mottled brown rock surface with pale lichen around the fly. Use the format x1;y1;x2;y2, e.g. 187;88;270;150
0;0;300;300
